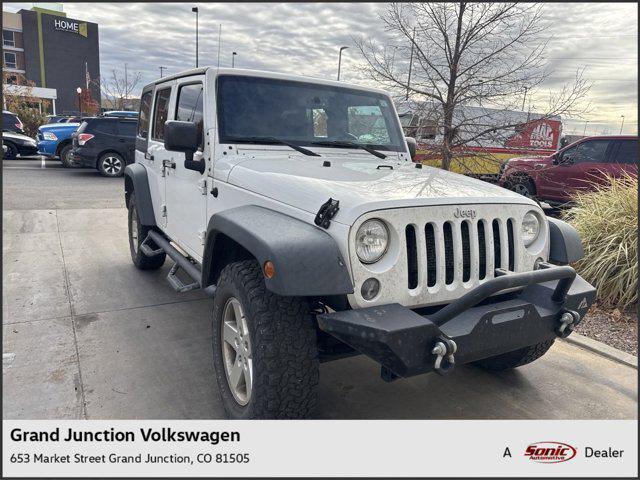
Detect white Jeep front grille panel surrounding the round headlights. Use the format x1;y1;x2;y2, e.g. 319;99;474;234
349;204;549;307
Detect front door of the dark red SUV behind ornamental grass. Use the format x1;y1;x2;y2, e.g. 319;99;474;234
538;139;612;201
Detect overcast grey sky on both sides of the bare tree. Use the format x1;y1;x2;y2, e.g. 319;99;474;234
3;2;638;134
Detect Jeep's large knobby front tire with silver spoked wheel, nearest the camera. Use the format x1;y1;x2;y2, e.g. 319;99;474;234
212;260;319;419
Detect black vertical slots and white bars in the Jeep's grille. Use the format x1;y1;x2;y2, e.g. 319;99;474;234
405;219;516;290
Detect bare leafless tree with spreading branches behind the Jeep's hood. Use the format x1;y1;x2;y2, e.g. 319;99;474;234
355;2;590;170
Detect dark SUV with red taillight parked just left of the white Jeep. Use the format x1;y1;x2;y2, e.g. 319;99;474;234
72;117;138;177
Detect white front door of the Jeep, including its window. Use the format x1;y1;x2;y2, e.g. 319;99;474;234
165;75;209;260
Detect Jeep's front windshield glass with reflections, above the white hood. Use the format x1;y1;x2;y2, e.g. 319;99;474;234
218;75;405;151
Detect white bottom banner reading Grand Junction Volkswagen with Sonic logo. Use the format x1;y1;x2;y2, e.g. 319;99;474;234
2;420;638;477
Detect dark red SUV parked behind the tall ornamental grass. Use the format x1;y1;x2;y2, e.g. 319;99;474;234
500;136;638;204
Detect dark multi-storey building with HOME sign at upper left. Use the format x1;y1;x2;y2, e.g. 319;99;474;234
2;4;101;114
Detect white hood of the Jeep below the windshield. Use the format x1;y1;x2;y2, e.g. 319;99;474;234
227;154;536;225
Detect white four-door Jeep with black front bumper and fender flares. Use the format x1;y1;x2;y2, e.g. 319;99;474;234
125;68;595;418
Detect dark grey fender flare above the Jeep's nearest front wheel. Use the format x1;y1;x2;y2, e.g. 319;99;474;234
202;205;353;297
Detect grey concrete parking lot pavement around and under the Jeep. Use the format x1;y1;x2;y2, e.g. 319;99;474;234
2;159;637;419
